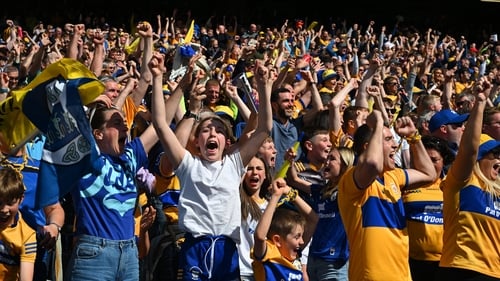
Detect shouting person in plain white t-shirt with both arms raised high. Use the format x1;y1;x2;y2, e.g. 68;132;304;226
149;54;274;281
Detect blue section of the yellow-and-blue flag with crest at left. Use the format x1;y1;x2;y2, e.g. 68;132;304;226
22;59;103;208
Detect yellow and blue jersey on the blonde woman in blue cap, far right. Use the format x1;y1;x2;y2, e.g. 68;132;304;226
440;173;500;278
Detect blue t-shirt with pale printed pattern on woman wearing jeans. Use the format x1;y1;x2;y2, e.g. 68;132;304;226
71;138;147;240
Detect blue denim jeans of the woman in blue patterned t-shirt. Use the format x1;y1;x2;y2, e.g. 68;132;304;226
64;235;139;281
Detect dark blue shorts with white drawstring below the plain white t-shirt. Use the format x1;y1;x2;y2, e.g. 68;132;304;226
178;233;240;281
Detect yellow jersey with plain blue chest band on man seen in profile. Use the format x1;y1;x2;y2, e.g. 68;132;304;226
338;167;411;281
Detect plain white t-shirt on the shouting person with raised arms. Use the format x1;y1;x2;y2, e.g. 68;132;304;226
175;151;245;243
